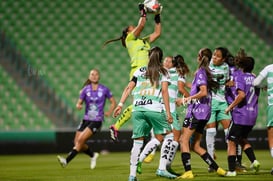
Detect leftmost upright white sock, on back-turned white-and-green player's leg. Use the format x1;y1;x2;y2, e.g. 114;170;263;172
130;140;143;177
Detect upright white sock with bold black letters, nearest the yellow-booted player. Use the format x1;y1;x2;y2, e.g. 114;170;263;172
158;133;173;170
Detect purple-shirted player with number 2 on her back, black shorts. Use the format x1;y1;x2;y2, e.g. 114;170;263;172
225;56;260;176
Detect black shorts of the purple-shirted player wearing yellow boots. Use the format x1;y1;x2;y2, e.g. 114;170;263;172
183;117;208;134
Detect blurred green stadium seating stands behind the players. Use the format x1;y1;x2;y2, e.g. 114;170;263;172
0;0;273;153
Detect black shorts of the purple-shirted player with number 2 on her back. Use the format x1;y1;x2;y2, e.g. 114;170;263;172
227;122;253;143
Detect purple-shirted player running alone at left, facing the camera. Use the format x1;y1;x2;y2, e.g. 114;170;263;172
57;69;116;169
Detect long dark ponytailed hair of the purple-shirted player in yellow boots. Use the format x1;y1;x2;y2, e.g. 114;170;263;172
198;48;219;91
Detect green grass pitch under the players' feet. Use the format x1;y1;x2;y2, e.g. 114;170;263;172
0;150;273;181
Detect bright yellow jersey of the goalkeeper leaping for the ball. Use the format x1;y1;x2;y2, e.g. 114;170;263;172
125;32;151;72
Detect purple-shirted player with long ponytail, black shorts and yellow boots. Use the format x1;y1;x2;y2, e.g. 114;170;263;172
174;48;226;179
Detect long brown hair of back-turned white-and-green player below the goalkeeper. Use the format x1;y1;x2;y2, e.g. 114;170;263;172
145;47;168;87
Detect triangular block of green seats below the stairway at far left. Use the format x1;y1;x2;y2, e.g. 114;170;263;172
0;67;53;131
